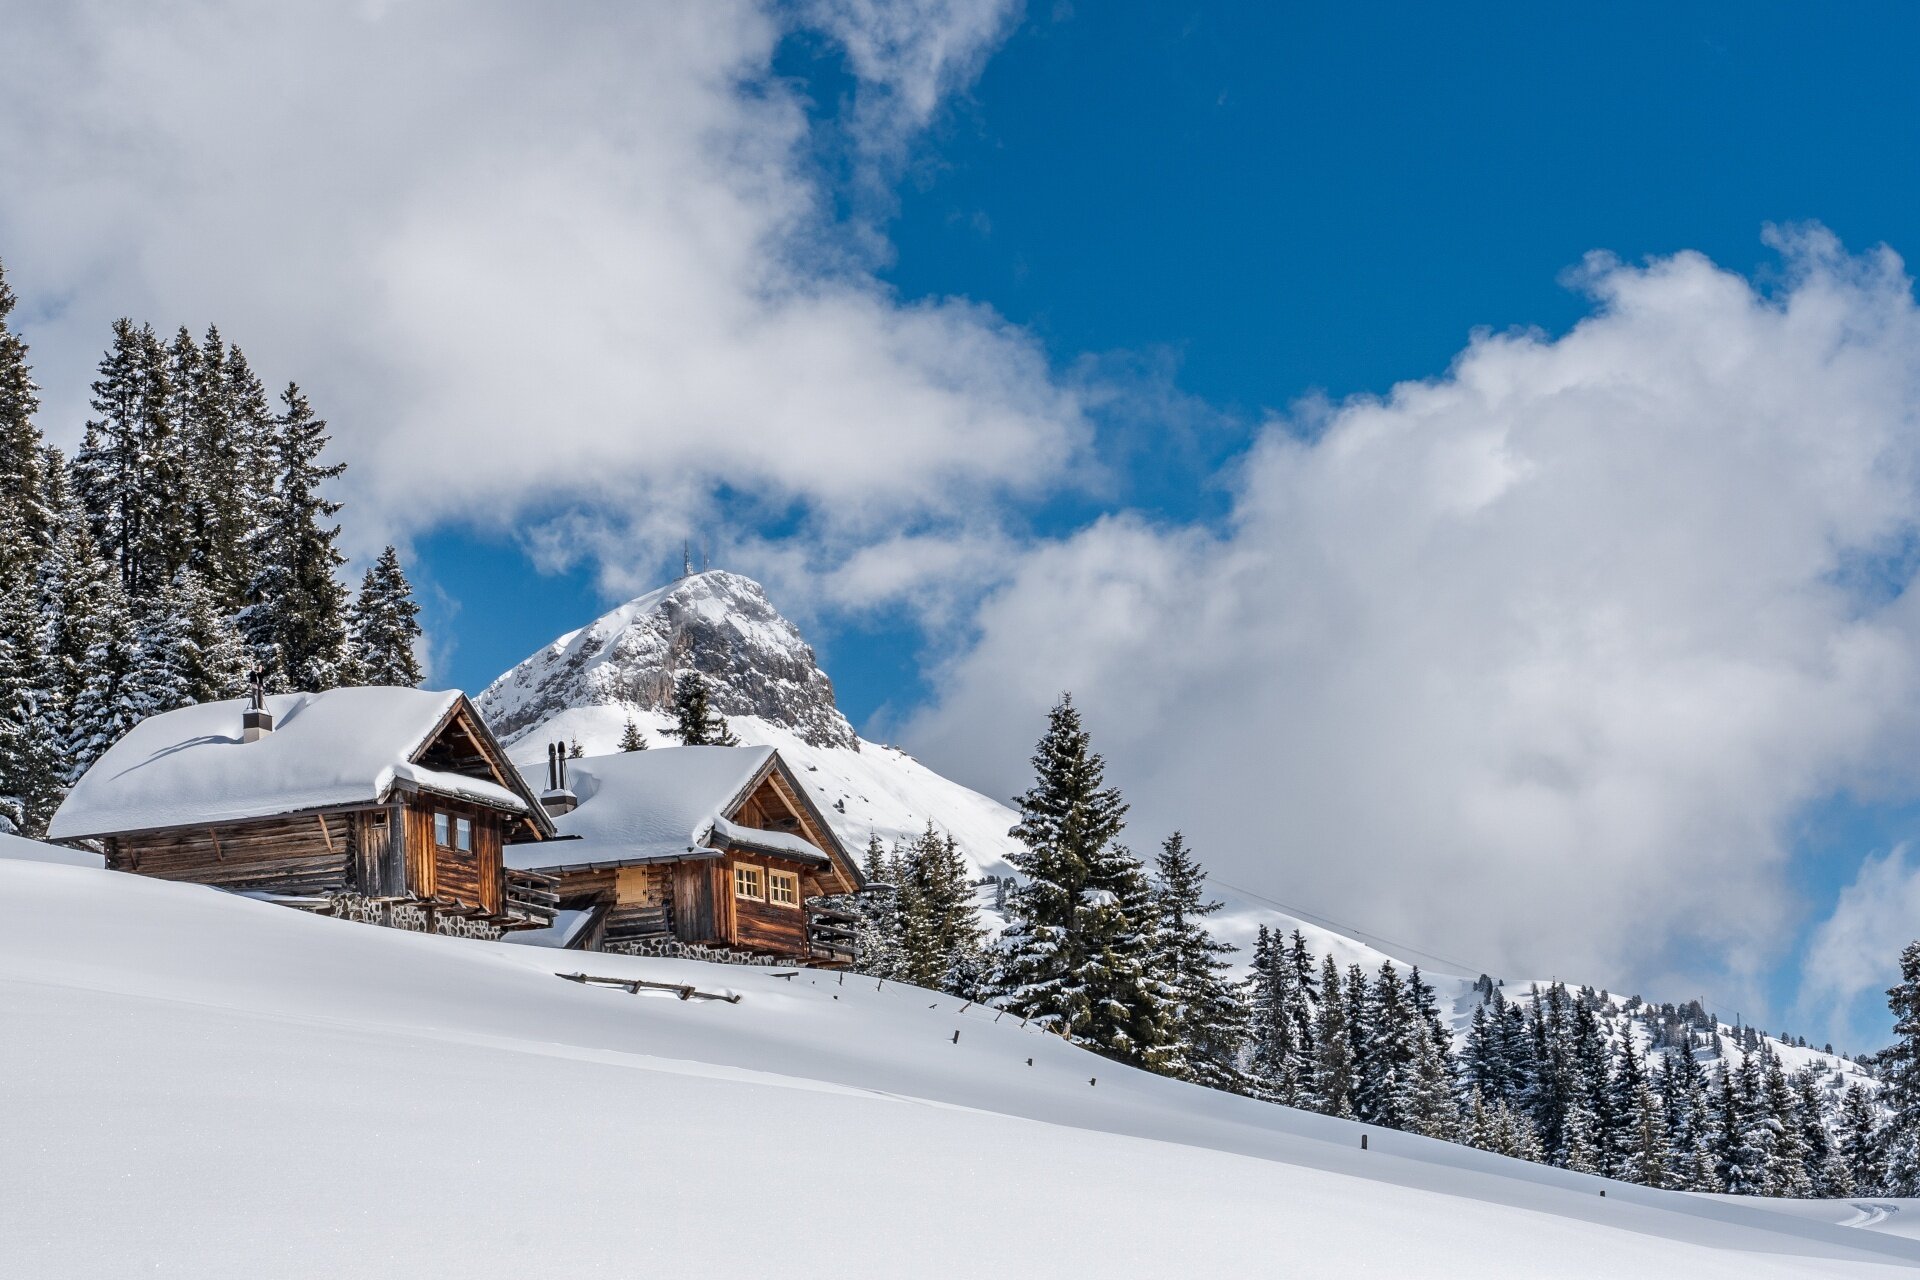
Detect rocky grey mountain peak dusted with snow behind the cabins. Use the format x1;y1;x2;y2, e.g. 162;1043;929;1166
478;570;860;750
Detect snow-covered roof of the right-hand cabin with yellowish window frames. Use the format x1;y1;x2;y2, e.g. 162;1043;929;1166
507;747;828;871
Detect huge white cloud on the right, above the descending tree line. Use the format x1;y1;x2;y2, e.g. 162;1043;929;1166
902;230;1920;984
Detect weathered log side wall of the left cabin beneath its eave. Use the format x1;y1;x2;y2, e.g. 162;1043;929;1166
106;814;353;894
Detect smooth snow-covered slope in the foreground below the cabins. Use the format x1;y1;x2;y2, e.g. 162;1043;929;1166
0;842;1920;1280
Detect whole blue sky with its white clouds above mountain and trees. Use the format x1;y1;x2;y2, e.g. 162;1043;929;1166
11;0;1920;1040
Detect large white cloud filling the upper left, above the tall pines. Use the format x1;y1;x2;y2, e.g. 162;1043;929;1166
0;0;1087;578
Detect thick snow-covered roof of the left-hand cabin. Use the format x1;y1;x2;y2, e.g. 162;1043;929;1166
48;687;528;841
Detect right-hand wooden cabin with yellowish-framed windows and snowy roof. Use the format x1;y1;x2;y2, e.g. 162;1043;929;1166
507;747;862;963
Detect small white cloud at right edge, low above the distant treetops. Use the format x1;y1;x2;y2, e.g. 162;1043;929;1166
1795;844;1920;1048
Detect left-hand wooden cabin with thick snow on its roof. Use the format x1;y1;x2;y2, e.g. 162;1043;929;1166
48;687;553;936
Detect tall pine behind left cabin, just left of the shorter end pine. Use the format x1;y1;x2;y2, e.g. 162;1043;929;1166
242;384;348;689
